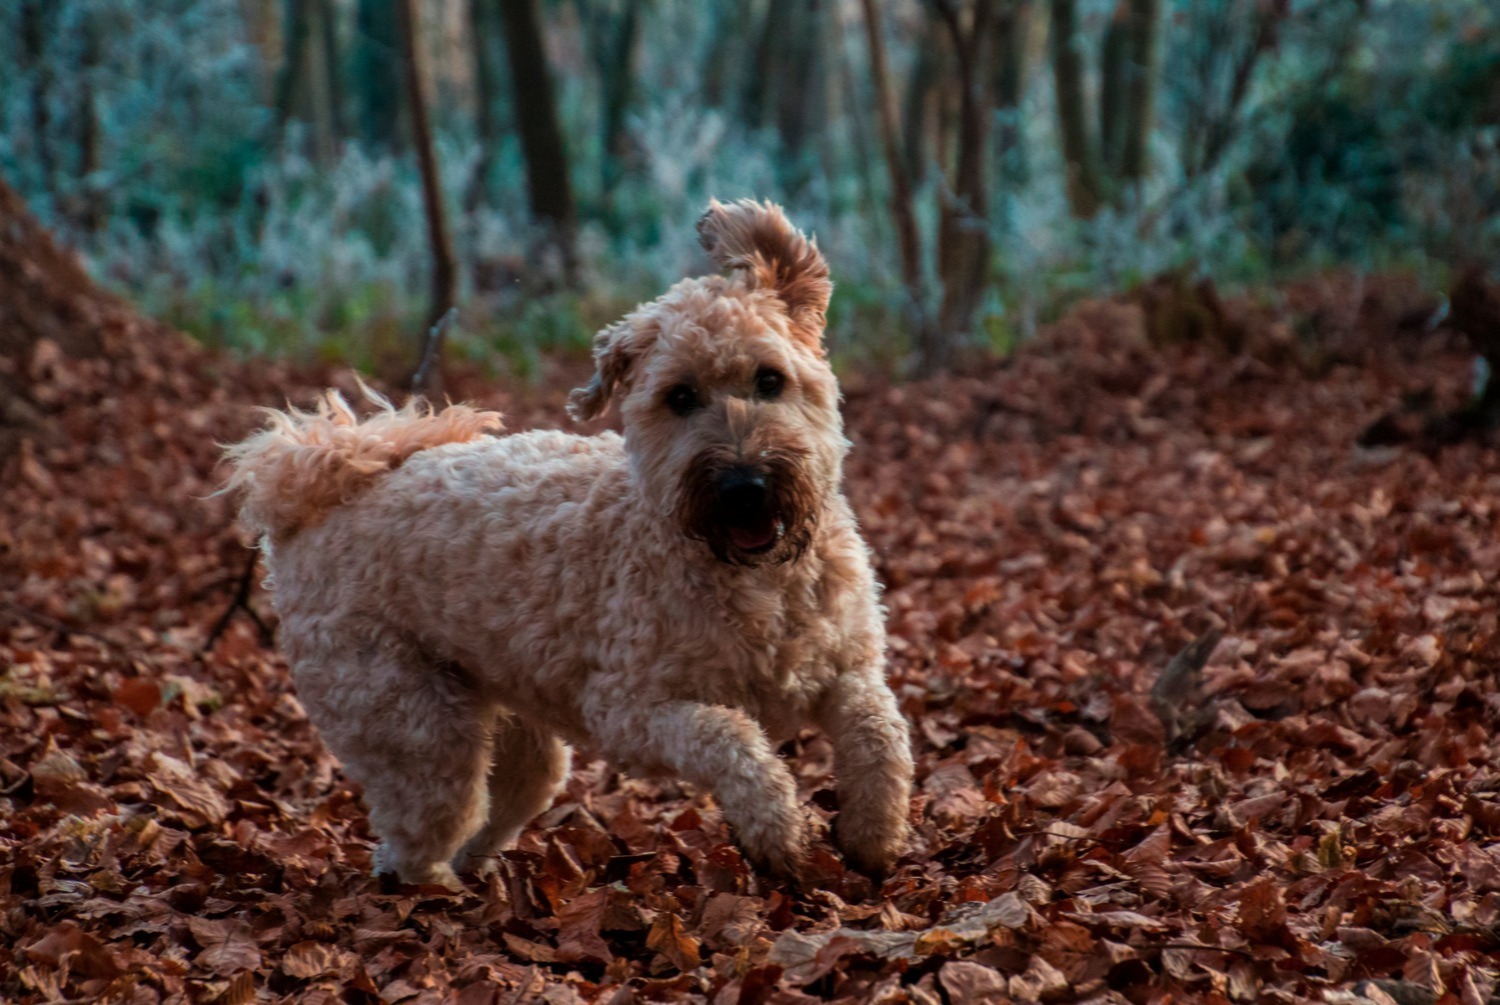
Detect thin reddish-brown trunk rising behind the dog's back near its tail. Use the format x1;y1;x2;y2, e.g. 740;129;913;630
396;0;458;399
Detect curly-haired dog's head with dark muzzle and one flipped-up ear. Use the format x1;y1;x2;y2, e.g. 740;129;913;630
569;201;848;566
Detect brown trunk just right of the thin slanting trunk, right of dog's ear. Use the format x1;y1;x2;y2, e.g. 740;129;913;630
924;0;995;371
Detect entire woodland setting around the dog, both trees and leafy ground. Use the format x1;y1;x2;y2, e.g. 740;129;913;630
0;0;1500;1005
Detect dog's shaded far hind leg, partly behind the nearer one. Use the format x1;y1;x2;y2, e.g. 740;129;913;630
453;716;573;876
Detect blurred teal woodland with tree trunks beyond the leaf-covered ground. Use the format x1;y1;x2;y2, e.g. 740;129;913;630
0;0;1500;382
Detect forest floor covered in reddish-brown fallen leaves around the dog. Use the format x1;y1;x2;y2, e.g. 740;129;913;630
0;262;1500;1005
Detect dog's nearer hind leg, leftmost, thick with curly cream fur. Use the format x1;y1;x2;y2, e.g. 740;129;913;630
296;645;494;887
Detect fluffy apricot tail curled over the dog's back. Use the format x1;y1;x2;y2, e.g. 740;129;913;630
219;384;501;540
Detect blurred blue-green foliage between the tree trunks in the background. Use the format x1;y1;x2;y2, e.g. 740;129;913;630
0;0;1500;372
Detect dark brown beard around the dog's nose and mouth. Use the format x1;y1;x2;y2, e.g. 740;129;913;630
675;447;822;567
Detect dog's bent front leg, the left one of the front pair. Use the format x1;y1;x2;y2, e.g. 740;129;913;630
596;696;807;879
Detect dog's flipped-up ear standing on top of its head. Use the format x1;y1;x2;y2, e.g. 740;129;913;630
698;200;834;353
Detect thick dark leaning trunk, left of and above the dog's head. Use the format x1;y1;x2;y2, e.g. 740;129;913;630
500;0;575;282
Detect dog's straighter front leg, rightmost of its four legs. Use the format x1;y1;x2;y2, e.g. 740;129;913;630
818;668;912;876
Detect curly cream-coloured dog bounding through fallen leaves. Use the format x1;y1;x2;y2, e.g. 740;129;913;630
225;201;912;887
